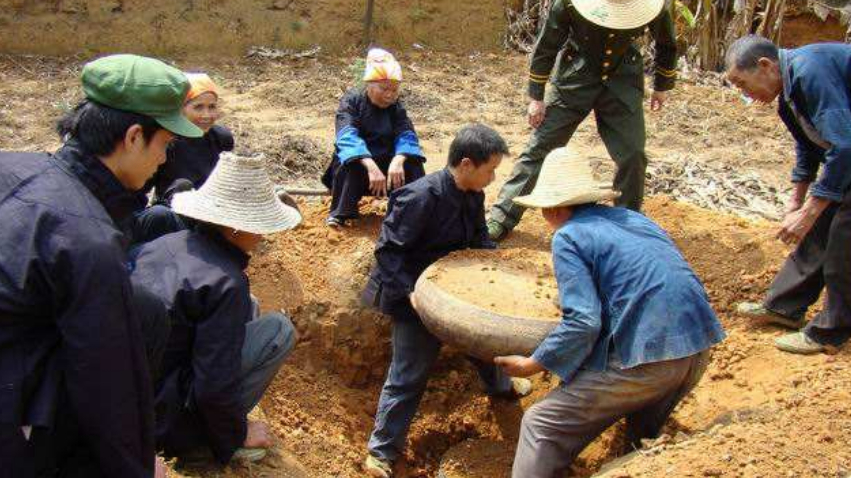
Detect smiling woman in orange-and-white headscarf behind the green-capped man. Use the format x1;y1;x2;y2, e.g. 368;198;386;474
132;73;234;244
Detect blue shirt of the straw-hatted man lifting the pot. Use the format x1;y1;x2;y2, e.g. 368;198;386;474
533;205;724;382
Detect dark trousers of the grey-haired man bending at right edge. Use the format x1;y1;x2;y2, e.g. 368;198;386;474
765;192;851;347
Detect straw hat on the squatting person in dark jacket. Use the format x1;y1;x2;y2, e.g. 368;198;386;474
171;153;301;234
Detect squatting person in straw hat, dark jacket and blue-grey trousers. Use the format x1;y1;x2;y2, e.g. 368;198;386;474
131;153;301;464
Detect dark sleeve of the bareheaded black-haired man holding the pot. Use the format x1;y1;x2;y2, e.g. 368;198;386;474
375;188;434;297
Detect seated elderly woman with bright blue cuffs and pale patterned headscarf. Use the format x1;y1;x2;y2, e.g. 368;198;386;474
322;48;426;227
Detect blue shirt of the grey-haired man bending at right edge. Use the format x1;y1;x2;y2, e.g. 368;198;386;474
778;43;851;202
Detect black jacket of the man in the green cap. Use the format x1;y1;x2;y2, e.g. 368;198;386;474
0;142;154;478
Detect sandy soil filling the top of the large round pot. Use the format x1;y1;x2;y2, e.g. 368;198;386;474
426;250;561;321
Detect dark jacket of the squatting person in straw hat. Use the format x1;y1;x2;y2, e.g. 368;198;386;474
132;228;252;463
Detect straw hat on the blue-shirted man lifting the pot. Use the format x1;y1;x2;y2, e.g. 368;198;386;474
514;148;620;209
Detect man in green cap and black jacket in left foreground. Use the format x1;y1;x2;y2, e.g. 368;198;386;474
0;55;201;478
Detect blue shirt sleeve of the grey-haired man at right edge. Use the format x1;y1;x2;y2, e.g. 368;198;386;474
800;73;851;202
